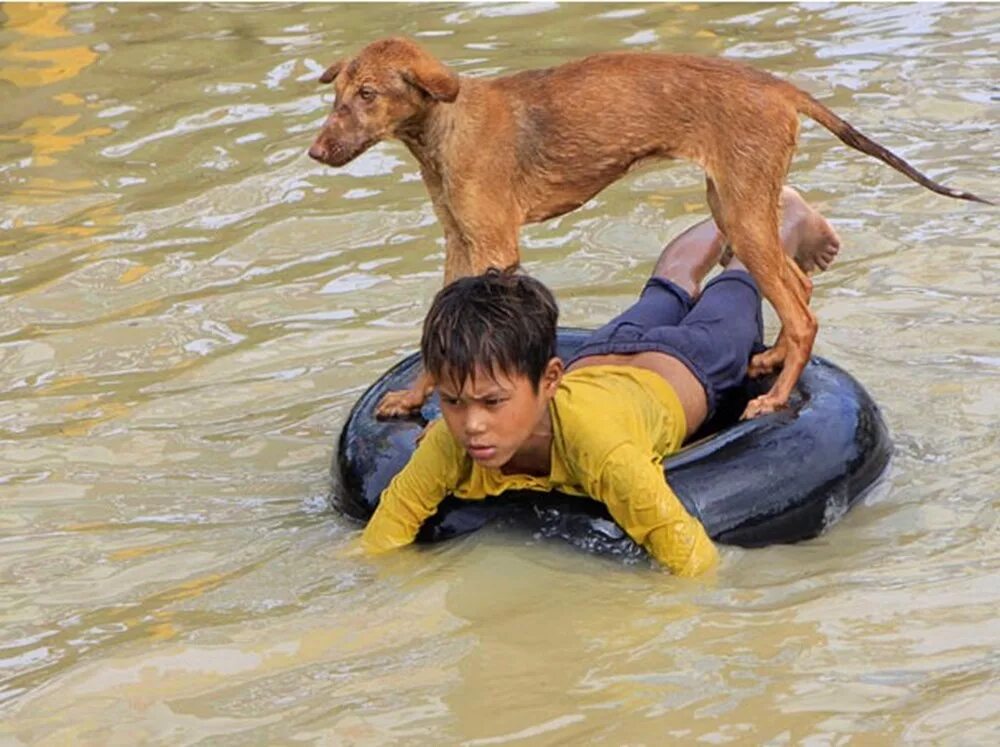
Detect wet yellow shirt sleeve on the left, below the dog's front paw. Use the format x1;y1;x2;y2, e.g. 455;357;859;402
361;420;463;553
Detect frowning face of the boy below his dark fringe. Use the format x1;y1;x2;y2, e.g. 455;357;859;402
438;358;563;469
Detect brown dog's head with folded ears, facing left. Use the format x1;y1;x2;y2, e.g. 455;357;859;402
309;38;459;166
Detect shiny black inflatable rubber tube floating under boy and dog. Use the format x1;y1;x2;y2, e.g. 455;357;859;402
331;328;892;555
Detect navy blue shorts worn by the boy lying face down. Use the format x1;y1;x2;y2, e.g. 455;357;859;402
569;270;764;417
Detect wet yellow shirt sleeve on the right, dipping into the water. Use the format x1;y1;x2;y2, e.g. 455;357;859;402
589;444;719;576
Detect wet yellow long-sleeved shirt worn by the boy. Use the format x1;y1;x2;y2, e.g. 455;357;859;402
362;366;718;576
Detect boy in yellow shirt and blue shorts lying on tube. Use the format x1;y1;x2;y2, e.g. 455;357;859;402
362;189;839;576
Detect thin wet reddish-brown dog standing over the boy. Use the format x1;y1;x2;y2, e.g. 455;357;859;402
309;38;992;417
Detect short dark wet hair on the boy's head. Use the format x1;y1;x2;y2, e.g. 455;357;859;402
420;268;559;392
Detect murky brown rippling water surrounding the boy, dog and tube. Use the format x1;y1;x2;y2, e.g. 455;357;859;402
0;3;1000;746
